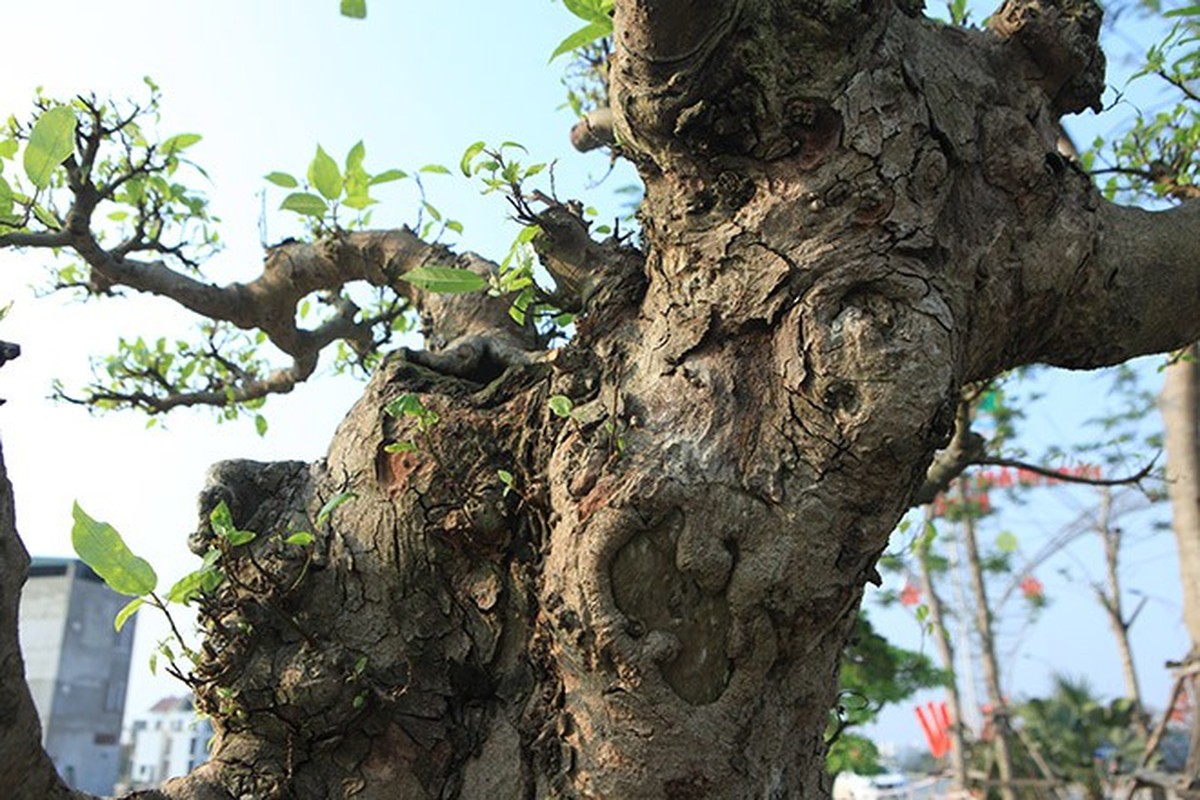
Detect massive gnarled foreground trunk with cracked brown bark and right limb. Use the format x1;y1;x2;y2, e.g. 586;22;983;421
0;0;1200;800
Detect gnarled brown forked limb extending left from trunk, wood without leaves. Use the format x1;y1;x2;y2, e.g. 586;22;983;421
0;219;539;413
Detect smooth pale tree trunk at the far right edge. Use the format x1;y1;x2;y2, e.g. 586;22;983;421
1159;344;1200;792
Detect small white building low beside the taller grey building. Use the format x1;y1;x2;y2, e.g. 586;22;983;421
127;697;212;789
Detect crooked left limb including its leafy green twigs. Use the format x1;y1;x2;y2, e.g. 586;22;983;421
0;92;541;413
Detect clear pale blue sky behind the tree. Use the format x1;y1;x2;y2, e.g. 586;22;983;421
0;0;1186;762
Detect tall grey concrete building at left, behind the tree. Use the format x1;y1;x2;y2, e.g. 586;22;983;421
19;558;134;795
